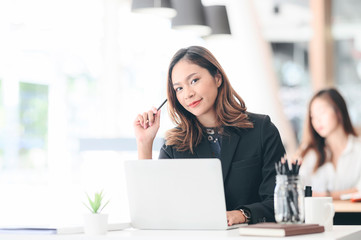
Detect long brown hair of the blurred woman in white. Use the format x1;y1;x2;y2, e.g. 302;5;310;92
300;88;357;171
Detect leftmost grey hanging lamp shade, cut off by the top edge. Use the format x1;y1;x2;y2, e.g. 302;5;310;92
132;0;177;18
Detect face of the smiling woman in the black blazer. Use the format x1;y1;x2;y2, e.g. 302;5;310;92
172;60;222;125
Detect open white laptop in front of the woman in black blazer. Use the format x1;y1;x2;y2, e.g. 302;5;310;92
125;158;246;230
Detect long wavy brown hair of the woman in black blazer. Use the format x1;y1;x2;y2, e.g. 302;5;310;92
165;46;253;153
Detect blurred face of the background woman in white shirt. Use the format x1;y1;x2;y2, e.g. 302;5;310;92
310;98;339;138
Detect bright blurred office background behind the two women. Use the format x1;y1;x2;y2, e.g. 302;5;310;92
0;0;361;224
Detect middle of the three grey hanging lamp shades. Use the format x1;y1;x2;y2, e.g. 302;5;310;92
172;0;211;36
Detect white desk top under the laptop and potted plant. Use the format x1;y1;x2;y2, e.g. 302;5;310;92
0;226;361;240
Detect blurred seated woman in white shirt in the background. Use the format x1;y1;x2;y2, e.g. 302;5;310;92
300;88;361;199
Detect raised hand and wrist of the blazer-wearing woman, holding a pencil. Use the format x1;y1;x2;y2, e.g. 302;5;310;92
134;107;160;159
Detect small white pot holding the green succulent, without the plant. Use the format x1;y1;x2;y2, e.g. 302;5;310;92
84;213;108;235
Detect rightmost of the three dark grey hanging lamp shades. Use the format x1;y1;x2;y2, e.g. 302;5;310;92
204;5;231;35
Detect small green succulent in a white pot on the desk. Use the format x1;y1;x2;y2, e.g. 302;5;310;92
84;191;109;235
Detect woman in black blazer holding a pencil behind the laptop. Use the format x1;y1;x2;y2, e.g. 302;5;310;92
134;46;285;225
